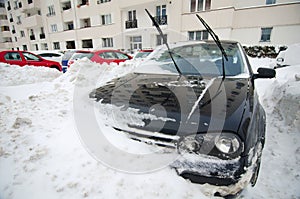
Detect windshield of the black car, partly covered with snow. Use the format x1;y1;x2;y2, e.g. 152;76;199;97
135;42;249;76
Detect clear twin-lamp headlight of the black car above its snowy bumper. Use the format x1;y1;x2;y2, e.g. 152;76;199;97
178;132;244;159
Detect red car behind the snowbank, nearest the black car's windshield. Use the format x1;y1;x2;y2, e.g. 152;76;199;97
68;50;132;66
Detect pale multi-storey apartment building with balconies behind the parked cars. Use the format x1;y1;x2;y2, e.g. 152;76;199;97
0;0;300;51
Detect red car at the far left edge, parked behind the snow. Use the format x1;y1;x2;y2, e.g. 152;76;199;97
0;50;62;71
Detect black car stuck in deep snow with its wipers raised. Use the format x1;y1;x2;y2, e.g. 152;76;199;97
90;41;275;196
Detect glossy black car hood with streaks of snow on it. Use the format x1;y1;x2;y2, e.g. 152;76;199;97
90;73;249;135
